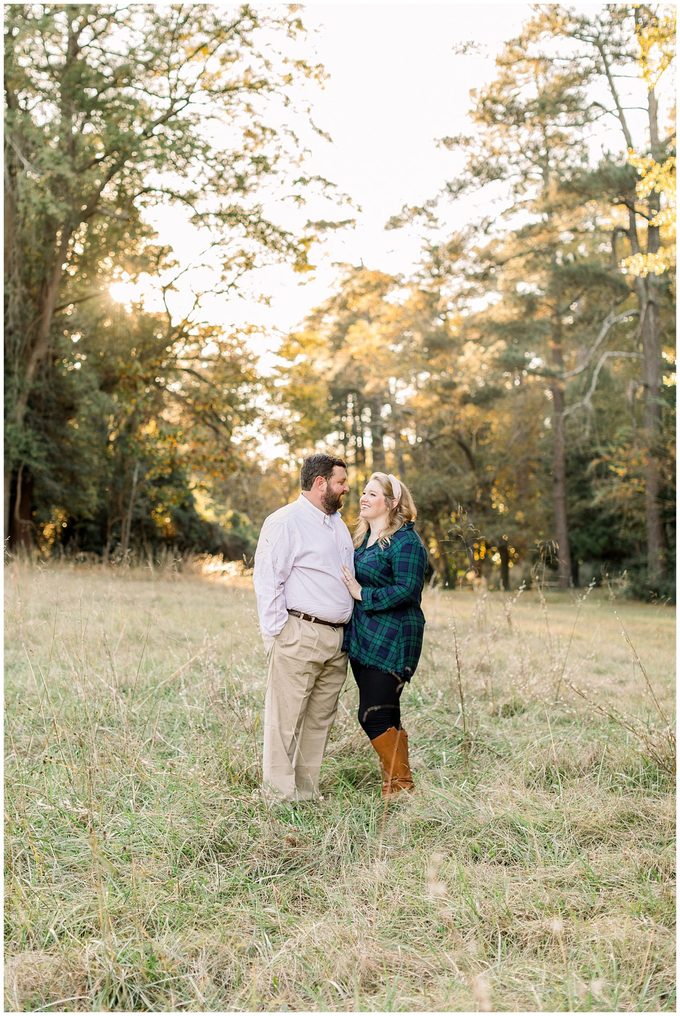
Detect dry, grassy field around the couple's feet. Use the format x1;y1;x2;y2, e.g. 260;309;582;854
5;563;675;1011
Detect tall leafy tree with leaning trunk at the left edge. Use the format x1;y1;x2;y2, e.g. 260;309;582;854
5;4;331;544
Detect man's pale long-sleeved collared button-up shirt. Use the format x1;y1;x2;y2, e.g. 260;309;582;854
253;494;354;638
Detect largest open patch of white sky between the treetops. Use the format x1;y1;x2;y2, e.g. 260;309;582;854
272;4;528;272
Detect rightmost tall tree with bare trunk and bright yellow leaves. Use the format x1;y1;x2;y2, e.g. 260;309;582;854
532;4;675;587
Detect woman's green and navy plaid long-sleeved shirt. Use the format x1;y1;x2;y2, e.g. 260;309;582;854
343;522;427;681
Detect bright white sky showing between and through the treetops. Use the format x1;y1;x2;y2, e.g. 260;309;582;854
115;2;658;372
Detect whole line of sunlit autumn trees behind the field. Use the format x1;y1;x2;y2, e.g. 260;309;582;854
5;4;675;595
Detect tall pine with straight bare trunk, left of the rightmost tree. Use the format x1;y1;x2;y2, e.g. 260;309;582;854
428;39;638;588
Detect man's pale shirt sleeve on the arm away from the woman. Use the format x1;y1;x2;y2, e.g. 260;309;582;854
253;521;293;640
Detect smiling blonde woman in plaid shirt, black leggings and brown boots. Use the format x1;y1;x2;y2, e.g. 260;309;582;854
343;472;427;797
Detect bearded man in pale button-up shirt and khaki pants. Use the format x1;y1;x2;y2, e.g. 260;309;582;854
254;455;354;801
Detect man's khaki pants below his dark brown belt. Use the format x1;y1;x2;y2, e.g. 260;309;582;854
263;615;347;801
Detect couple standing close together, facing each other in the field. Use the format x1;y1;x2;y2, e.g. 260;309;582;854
254;454;427;801
